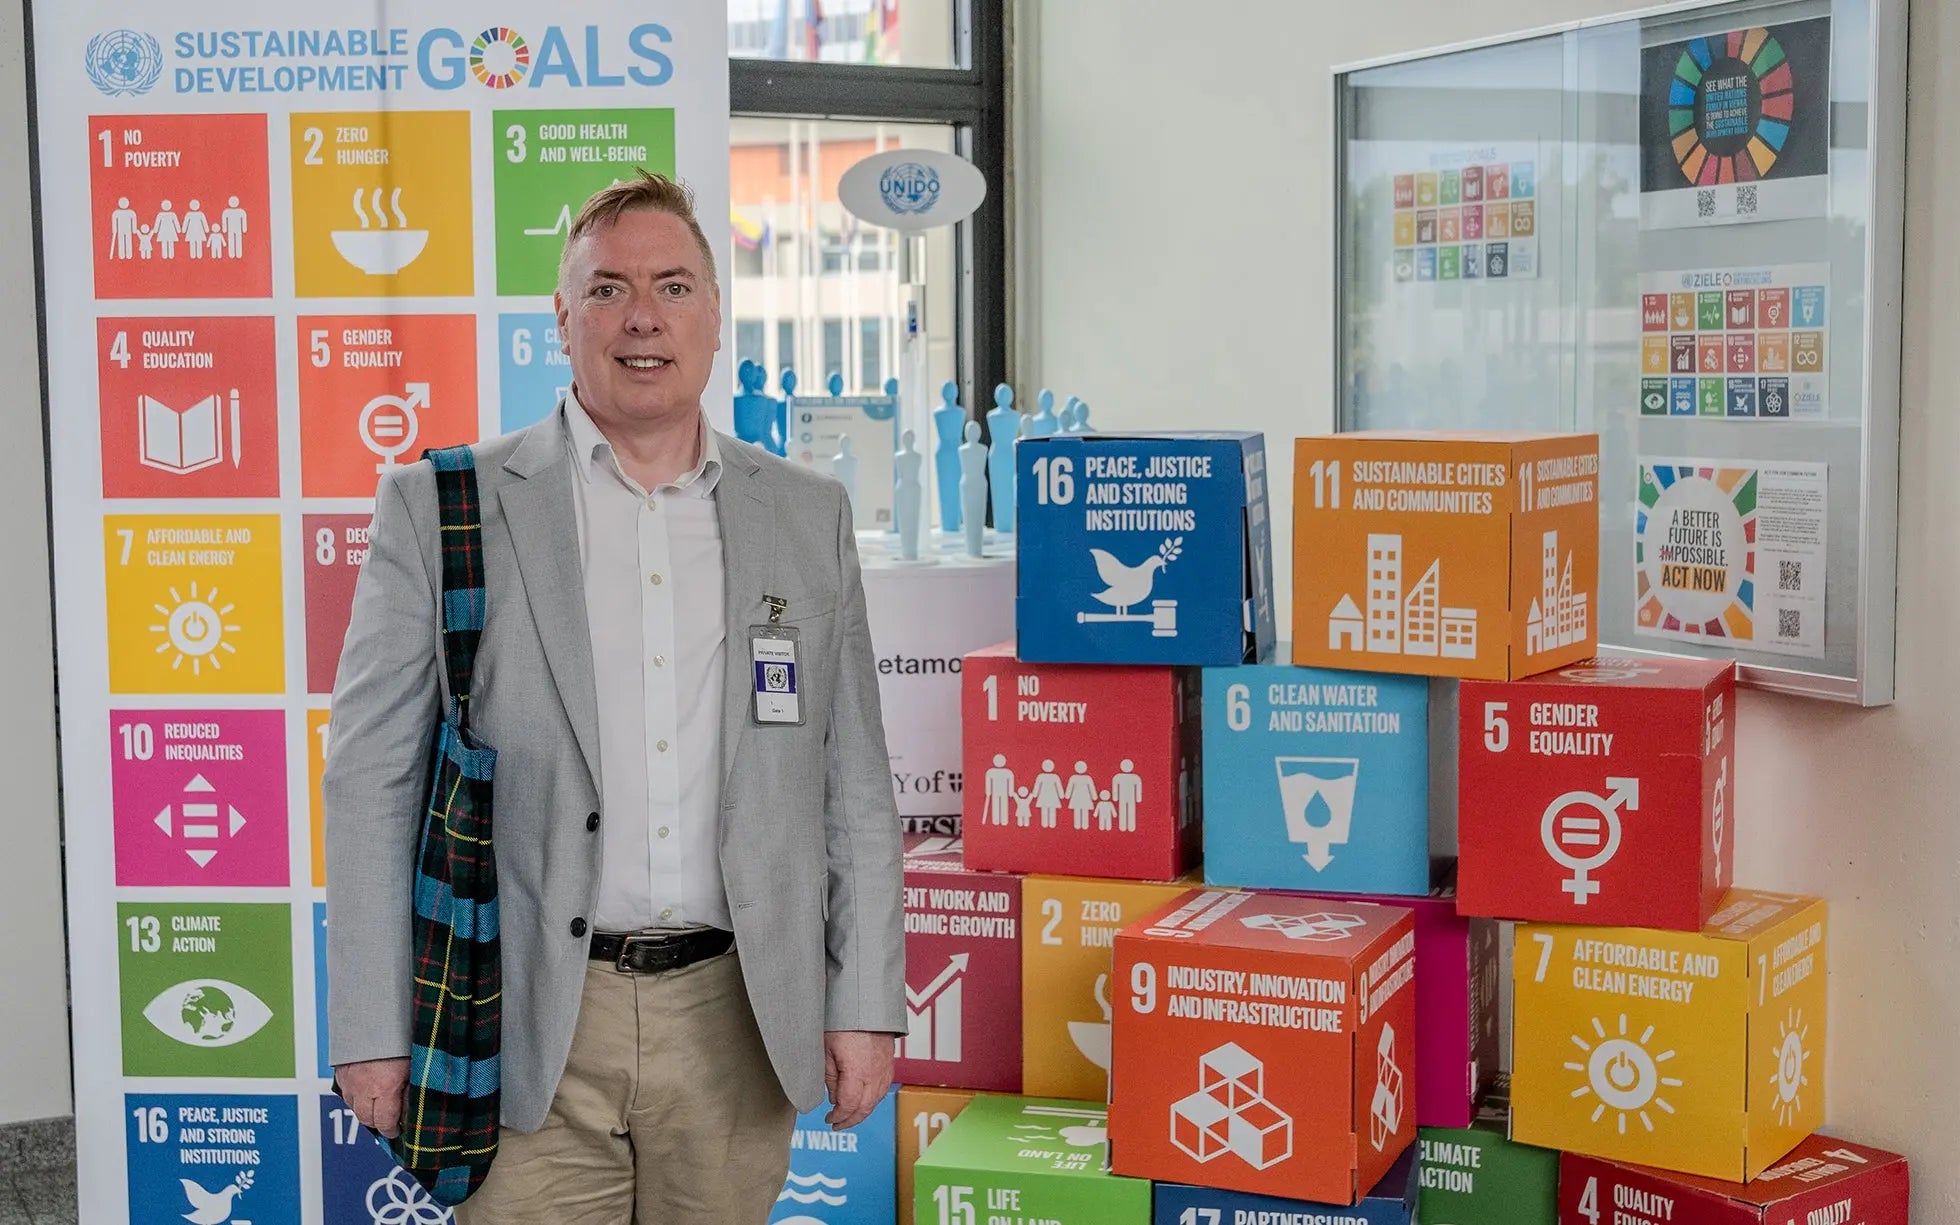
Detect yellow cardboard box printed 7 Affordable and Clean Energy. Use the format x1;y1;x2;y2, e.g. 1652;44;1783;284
1513;890;1825;1182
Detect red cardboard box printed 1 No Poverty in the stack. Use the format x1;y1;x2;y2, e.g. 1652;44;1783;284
960;643;1201;880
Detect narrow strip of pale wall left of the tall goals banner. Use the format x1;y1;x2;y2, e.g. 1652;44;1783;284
0;4;73;1123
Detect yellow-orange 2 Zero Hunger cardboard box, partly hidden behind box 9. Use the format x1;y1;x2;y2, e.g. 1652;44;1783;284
1021;876;1192;1102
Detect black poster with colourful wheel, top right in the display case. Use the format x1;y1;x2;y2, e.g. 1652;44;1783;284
1641;18;1831;229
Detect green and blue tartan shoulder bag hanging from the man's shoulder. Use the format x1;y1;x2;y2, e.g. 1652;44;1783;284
388;447;504;1205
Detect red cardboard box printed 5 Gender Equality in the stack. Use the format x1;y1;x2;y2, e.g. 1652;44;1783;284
1456;659;1735;931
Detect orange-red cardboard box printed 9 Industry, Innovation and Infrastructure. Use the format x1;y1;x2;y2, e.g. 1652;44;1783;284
1109;890;1415;1203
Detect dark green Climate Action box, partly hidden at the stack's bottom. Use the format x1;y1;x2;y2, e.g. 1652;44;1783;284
1415;1080;1558;1225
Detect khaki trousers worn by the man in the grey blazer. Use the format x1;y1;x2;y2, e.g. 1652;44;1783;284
457;951;796;1225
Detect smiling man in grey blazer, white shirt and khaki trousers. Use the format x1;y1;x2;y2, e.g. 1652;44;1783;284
323;172;906;1225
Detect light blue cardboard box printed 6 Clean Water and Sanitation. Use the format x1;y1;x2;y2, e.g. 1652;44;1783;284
1201;645;1429;894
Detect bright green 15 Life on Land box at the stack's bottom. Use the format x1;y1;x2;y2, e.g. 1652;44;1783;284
911;1094;1144;1225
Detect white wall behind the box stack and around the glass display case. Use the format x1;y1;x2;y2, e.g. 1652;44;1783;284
1015;0;1960;1223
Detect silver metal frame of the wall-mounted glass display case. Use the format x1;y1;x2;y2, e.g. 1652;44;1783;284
1329;0;1907;706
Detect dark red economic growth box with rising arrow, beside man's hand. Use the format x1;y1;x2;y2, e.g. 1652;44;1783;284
898;835;1021;1094
